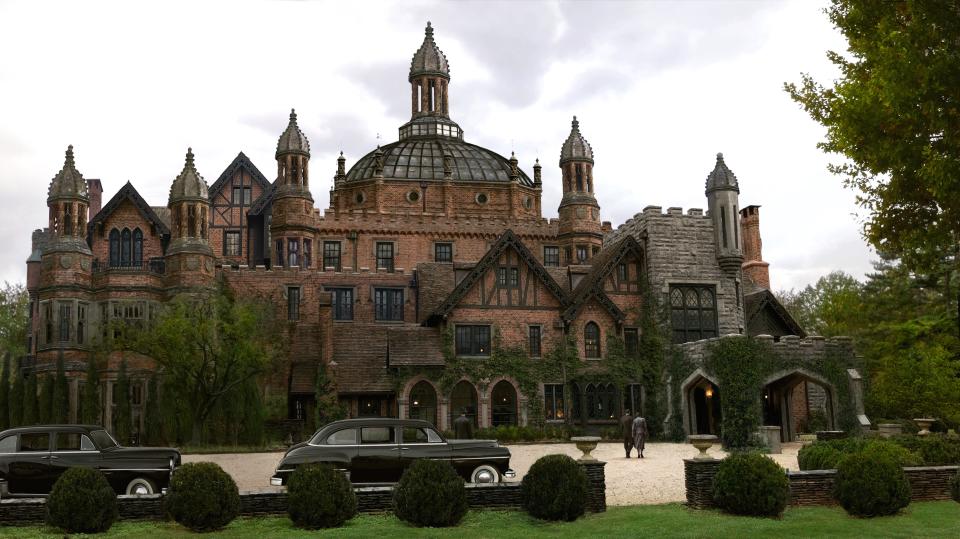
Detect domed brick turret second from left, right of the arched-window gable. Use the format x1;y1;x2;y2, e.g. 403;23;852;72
166;148;213;287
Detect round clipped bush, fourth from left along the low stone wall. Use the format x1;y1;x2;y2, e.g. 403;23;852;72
393;459;467;528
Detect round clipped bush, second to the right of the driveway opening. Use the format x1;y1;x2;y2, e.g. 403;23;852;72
833;451;910;517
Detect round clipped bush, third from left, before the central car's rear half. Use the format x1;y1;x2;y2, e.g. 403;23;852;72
287;464;357;530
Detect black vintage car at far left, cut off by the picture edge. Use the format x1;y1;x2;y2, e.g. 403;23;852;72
0;425;180;496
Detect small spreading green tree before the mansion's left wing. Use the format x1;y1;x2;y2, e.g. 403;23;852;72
131;284;285;444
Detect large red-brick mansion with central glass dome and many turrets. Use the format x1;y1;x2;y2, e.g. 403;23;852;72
27;24;853;436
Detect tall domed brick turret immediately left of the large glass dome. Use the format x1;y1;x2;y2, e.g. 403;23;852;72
270;109;316;267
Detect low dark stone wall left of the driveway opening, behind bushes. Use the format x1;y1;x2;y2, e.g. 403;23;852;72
0;461;607;526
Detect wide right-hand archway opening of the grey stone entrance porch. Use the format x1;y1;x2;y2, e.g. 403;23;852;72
763;370;835;442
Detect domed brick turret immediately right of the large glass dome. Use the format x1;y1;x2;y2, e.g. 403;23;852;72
559;116;603;264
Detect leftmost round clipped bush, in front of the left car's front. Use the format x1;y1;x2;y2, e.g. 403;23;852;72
47;467;118;533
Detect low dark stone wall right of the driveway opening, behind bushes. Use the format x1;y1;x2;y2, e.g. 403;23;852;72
683;459;957;509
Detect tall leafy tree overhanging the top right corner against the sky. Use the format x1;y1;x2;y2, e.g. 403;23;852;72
785;0;960;335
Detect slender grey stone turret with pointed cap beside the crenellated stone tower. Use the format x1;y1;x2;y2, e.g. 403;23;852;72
706;153;743;274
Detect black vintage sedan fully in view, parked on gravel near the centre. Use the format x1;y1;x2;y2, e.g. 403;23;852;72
270;418;516;486
